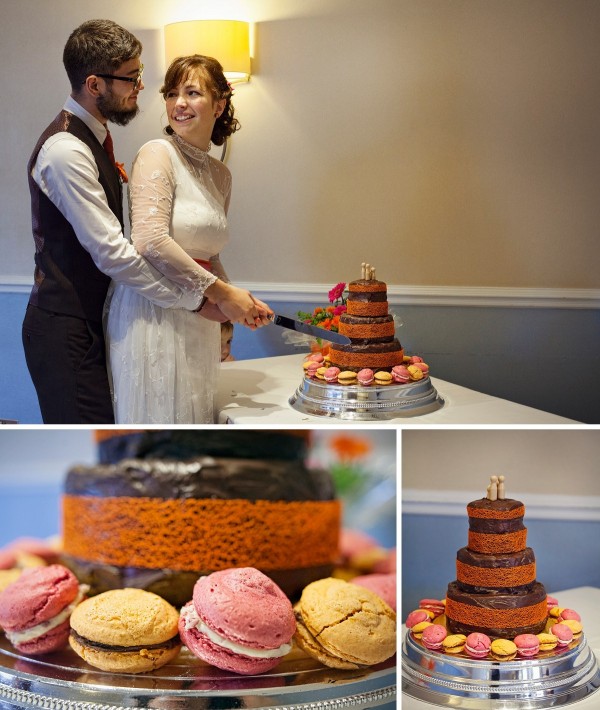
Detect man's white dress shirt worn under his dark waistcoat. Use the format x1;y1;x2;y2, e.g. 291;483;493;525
32;97;201;310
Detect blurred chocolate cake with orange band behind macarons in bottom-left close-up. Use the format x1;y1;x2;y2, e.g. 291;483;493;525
62;430;340;605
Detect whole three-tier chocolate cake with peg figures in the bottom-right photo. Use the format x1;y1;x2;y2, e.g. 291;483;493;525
446;476;548;639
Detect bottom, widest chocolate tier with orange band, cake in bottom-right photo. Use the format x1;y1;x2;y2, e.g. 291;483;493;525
446;582;548;639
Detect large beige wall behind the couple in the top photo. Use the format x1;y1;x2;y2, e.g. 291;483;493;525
0;0;600;289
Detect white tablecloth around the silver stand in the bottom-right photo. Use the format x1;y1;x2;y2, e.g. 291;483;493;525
402;587;600;710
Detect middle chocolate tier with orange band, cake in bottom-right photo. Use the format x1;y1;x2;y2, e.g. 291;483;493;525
456;547;535;594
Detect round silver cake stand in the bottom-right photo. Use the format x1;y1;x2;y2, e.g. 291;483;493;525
402;632;600;710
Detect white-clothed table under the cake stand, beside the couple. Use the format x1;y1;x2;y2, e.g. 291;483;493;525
215;355;578;426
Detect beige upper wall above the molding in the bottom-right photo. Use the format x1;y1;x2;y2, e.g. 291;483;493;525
402;430;600;497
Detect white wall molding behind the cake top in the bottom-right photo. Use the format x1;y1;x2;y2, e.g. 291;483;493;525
402;488;600;522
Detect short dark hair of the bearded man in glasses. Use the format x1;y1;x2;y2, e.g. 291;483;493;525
63;20;142;92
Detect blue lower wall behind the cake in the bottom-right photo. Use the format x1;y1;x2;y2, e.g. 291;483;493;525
401;514;600;620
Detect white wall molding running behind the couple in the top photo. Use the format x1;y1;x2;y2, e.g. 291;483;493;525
0;275;600;309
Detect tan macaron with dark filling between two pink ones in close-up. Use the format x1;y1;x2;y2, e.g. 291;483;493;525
69;588;181;673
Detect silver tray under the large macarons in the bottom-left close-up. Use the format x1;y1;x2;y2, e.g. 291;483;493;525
0;634;396;710
